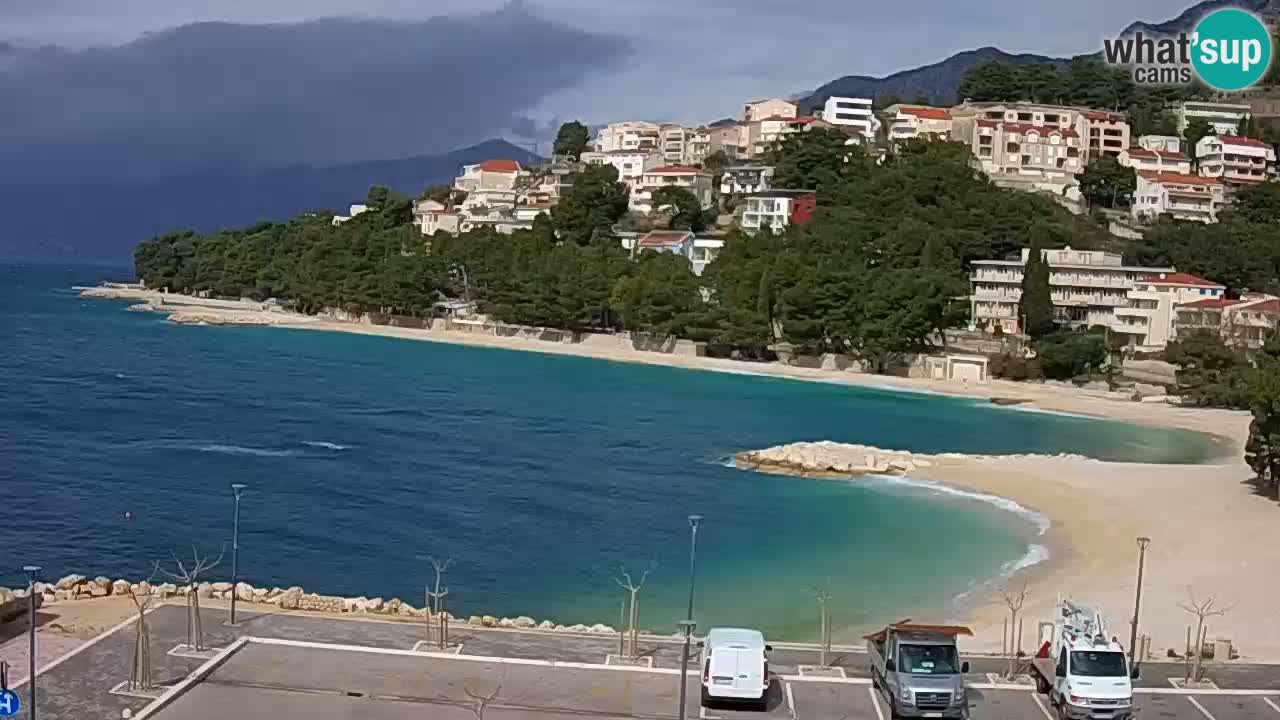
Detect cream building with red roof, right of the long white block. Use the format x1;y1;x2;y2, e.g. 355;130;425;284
1110;273;1226;351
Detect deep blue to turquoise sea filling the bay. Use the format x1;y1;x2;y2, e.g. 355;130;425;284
0;266;1213;638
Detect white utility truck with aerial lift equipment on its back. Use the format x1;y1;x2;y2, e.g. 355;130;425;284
1032;600;1138;720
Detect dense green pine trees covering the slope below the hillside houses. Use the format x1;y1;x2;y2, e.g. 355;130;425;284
136;135;1107;366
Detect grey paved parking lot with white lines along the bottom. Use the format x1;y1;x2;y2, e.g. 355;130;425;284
17;606;1280;720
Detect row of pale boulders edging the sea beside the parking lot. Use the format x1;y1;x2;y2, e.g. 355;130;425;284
0;574;618;634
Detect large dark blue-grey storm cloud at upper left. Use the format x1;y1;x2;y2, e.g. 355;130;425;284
0;4;626;177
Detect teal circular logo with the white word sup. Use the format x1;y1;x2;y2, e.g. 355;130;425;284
1192;8;1271;90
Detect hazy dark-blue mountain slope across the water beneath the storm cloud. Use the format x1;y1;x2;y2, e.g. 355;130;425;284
0;140;539;260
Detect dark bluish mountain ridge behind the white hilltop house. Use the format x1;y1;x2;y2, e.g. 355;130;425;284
800;47;1066;110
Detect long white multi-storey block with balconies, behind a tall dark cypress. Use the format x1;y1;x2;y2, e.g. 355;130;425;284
969;247;1174;333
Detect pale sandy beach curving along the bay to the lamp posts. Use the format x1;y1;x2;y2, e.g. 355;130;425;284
82;290;1280;660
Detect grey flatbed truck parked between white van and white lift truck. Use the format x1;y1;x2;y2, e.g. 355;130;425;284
865;620;973;719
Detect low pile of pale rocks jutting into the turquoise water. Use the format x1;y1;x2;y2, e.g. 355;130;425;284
733;441;933;477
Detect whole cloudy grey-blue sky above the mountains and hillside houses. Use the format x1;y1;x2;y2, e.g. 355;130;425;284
0;0;1189;176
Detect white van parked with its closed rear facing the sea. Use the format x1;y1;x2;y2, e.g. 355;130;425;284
699;628;773;706
